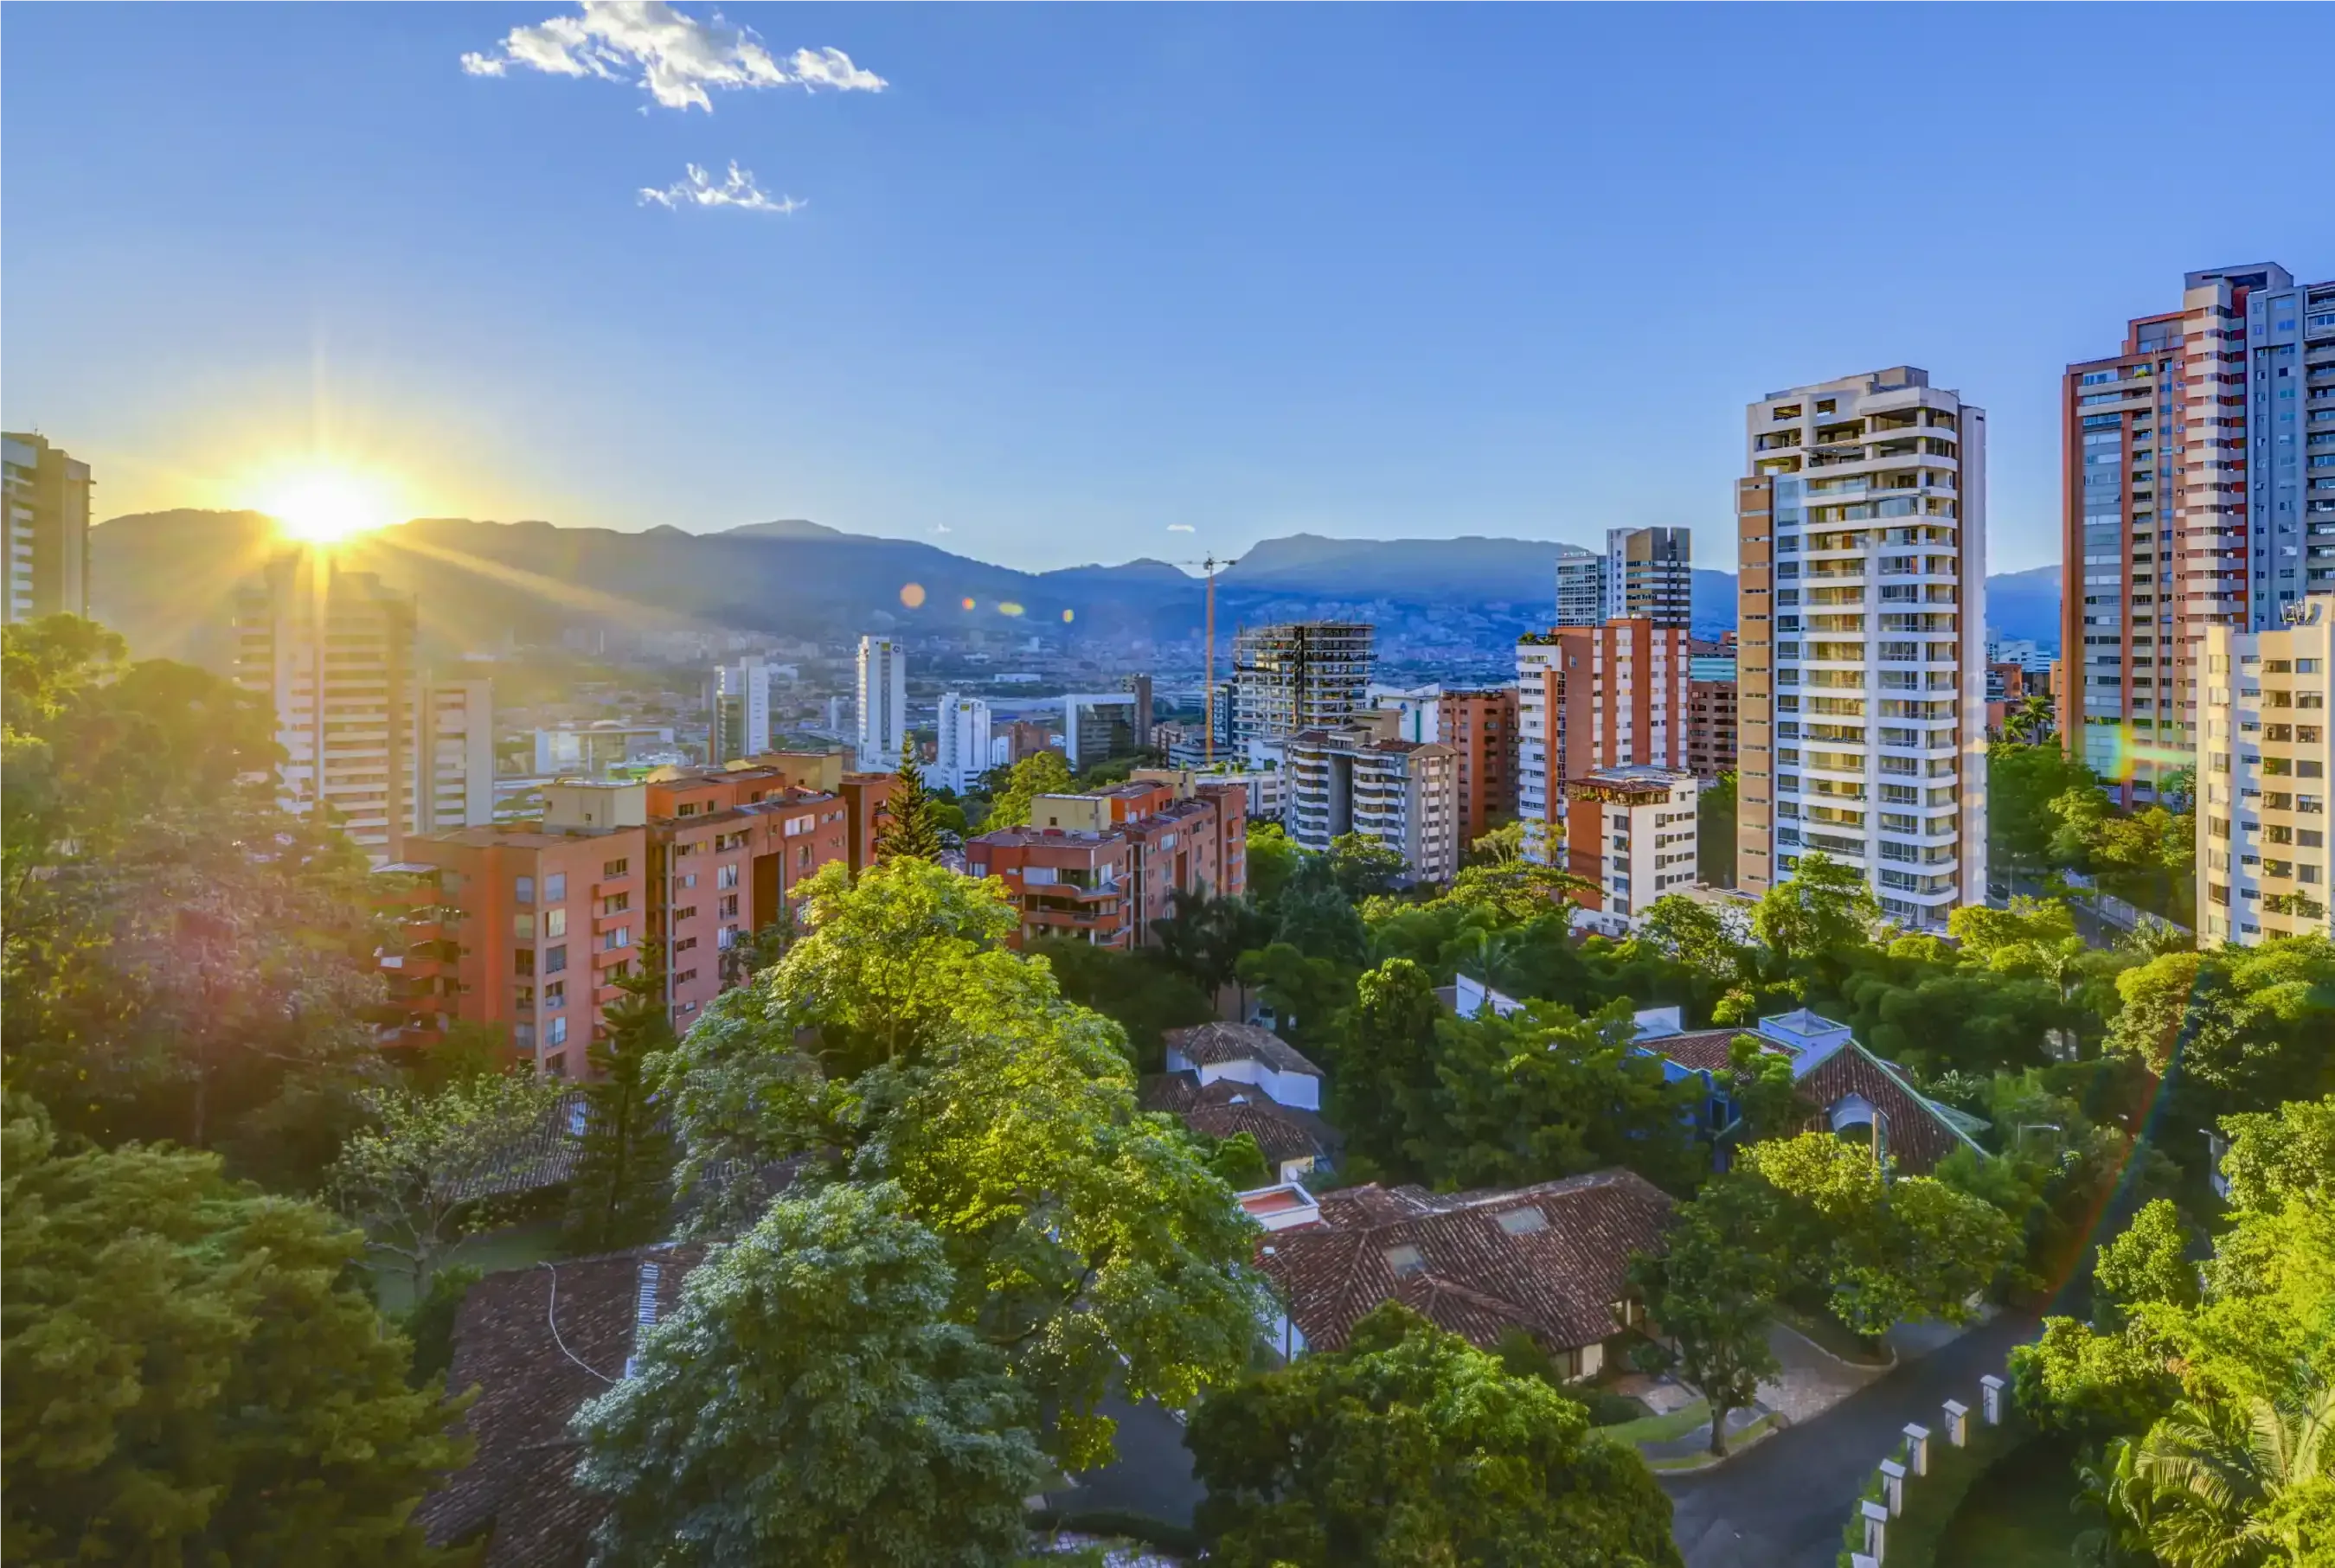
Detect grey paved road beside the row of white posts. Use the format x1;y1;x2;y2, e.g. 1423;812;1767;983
1663;1314;2038;1568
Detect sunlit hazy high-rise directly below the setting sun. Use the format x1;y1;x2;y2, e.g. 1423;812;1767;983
234;551;420;861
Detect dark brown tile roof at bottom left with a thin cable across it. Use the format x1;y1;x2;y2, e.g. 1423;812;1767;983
415;1246;705;1568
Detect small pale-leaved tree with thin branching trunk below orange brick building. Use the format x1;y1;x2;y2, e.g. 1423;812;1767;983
331;1073;558;1300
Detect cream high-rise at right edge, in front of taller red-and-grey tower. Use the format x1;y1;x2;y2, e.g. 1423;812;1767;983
2195;597;2335;947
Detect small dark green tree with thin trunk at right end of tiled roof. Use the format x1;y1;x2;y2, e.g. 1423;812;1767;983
1630;1178;1784;1458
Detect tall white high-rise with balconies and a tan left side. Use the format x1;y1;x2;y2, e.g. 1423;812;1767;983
1735;367;1987;929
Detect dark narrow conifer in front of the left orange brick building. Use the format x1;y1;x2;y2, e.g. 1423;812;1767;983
565;950;677;1253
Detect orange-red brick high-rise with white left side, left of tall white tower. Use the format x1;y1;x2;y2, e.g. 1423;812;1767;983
1516;618;1688;863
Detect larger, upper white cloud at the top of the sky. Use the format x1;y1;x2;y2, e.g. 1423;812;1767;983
462;0;885;112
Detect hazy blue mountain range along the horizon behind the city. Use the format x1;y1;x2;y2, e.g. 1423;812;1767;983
91;511;2057;665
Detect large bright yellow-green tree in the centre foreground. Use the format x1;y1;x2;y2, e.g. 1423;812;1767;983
658;859;1259;1470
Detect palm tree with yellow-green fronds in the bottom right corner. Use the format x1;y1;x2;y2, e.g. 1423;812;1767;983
2134;1367;2335;1568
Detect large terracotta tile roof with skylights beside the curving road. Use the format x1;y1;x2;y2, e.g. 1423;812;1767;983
1259;1171;1671;1351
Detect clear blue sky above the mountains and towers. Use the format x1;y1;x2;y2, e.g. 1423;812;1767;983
13;0;2335;569
